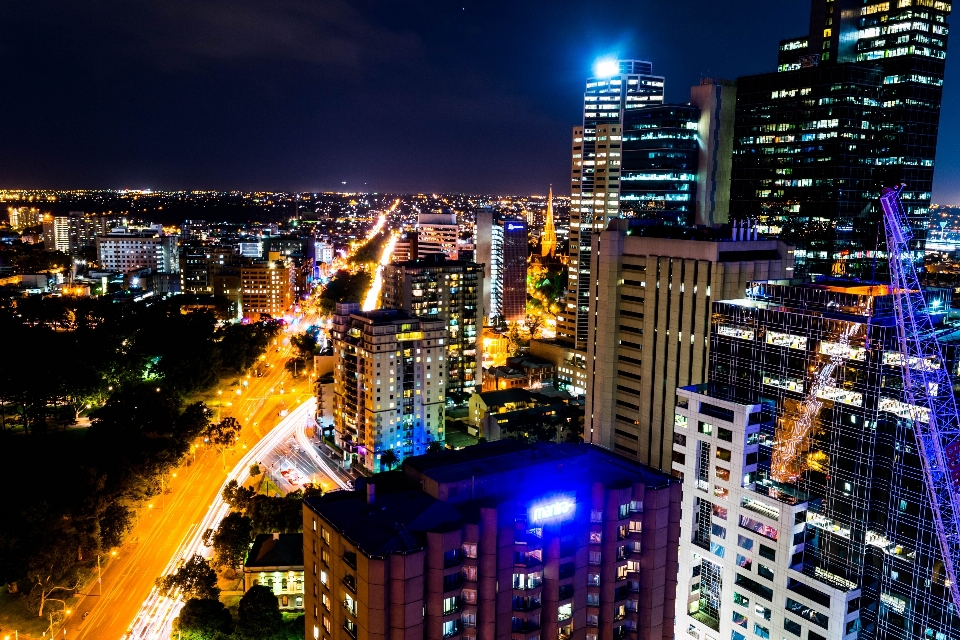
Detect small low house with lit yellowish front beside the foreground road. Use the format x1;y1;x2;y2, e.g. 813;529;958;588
243;533;303;611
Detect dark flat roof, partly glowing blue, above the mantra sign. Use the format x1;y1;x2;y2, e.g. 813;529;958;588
305;440;677;557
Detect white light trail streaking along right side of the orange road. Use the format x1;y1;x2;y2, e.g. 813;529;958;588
123;397;316;640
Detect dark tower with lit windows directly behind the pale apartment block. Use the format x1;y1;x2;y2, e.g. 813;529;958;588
380;254;484;404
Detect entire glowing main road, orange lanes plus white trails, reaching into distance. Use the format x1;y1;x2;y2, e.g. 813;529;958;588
65;208;399;640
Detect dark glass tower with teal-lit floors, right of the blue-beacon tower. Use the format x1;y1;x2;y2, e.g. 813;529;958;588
620;104;700;226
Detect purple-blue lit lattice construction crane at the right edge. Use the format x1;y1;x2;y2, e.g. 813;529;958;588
880;185;960;610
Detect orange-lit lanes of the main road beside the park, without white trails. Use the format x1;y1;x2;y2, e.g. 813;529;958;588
68;324;322;640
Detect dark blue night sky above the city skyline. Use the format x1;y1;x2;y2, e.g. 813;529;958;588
0;0;960;204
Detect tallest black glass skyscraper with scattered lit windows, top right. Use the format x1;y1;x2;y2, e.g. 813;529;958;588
731;0;951;278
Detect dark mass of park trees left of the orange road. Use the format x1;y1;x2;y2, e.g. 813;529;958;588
0;298;279;612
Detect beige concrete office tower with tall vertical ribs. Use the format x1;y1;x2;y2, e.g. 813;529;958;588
584;219;793;473
